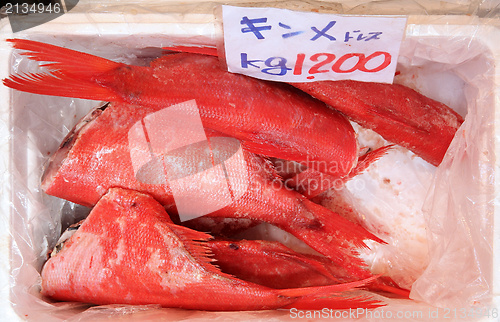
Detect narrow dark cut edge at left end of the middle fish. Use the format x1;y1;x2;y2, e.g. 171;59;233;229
41;102;110;191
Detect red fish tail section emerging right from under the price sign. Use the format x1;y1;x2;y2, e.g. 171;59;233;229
292;80;464;166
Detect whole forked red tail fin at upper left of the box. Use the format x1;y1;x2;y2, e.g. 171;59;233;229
3;39;124;101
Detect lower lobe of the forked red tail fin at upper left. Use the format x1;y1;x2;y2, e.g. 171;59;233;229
3;72;119;101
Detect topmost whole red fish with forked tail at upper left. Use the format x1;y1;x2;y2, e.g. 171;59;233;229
3;39;358;177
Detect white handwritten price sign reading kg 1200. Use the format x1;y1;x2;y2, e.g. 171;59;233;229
222;6;406;83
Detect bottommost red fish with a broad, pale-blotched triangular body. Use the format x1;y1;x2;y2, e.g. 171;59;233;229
41;188;381;311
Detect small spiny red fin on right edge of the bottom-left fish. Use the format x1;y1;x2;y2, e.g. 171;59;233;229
165;224;233;278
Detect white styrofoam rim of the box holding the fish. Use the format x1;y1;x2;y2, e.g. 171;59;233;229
0;13;500;321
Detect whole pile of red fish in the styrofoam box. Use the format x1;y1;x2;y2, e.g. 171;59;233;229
3;39;463;310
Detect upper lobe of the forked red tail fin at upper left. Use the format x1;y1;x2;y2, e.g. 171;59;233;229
7;39;124;78
